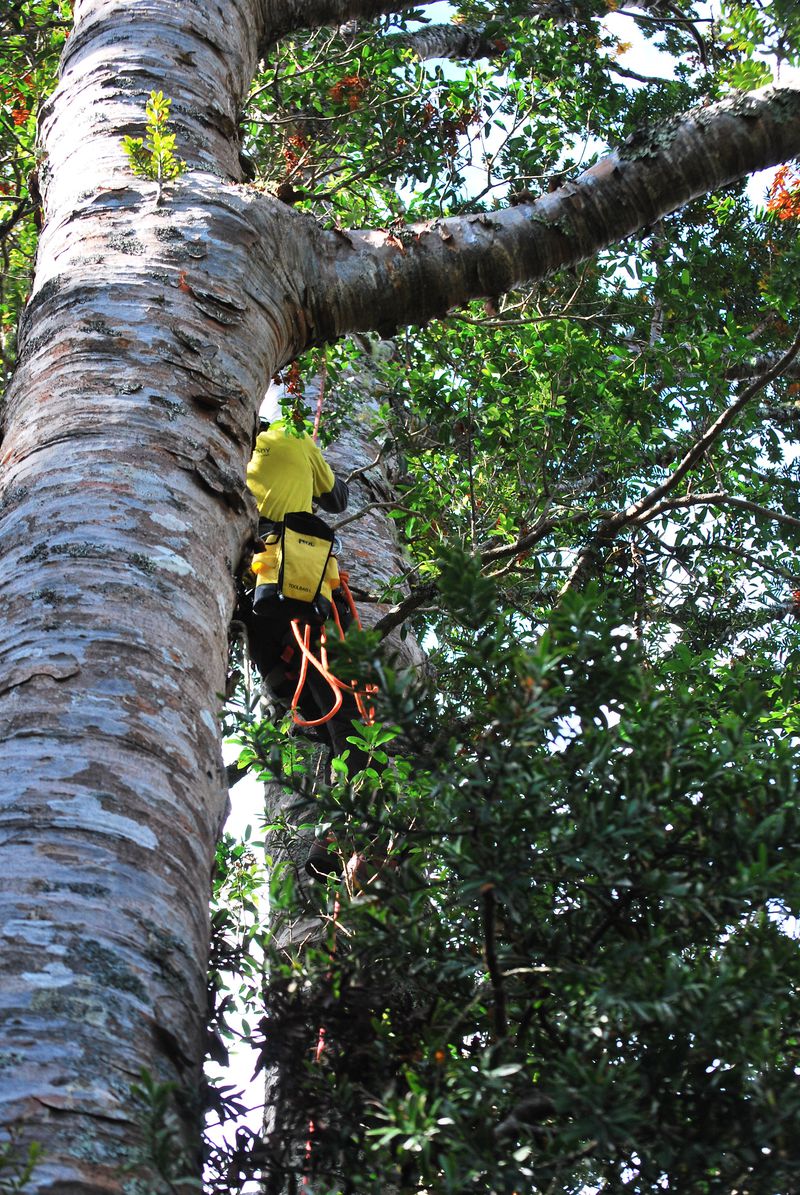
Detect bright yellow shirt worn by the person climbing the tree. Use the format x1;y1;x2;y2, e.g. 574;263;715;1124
248;419;336;522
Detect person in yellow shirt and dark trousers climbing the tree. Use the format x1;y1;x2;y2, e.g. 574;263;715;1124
237;391;368;878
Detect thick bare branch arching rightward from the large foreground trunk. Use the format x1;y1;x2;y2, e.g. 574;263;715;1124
297;86;800;343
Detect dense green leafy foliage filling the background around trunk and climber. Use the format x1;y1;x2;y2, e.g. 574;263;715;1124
6;0;800;1195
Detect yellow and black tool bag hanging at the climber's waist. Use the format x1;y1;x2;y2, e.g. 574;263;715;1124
250;510;340;623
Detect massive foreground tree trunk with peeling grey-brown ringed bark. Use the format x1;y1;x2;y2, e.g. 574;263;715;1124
0;0;276;1191
